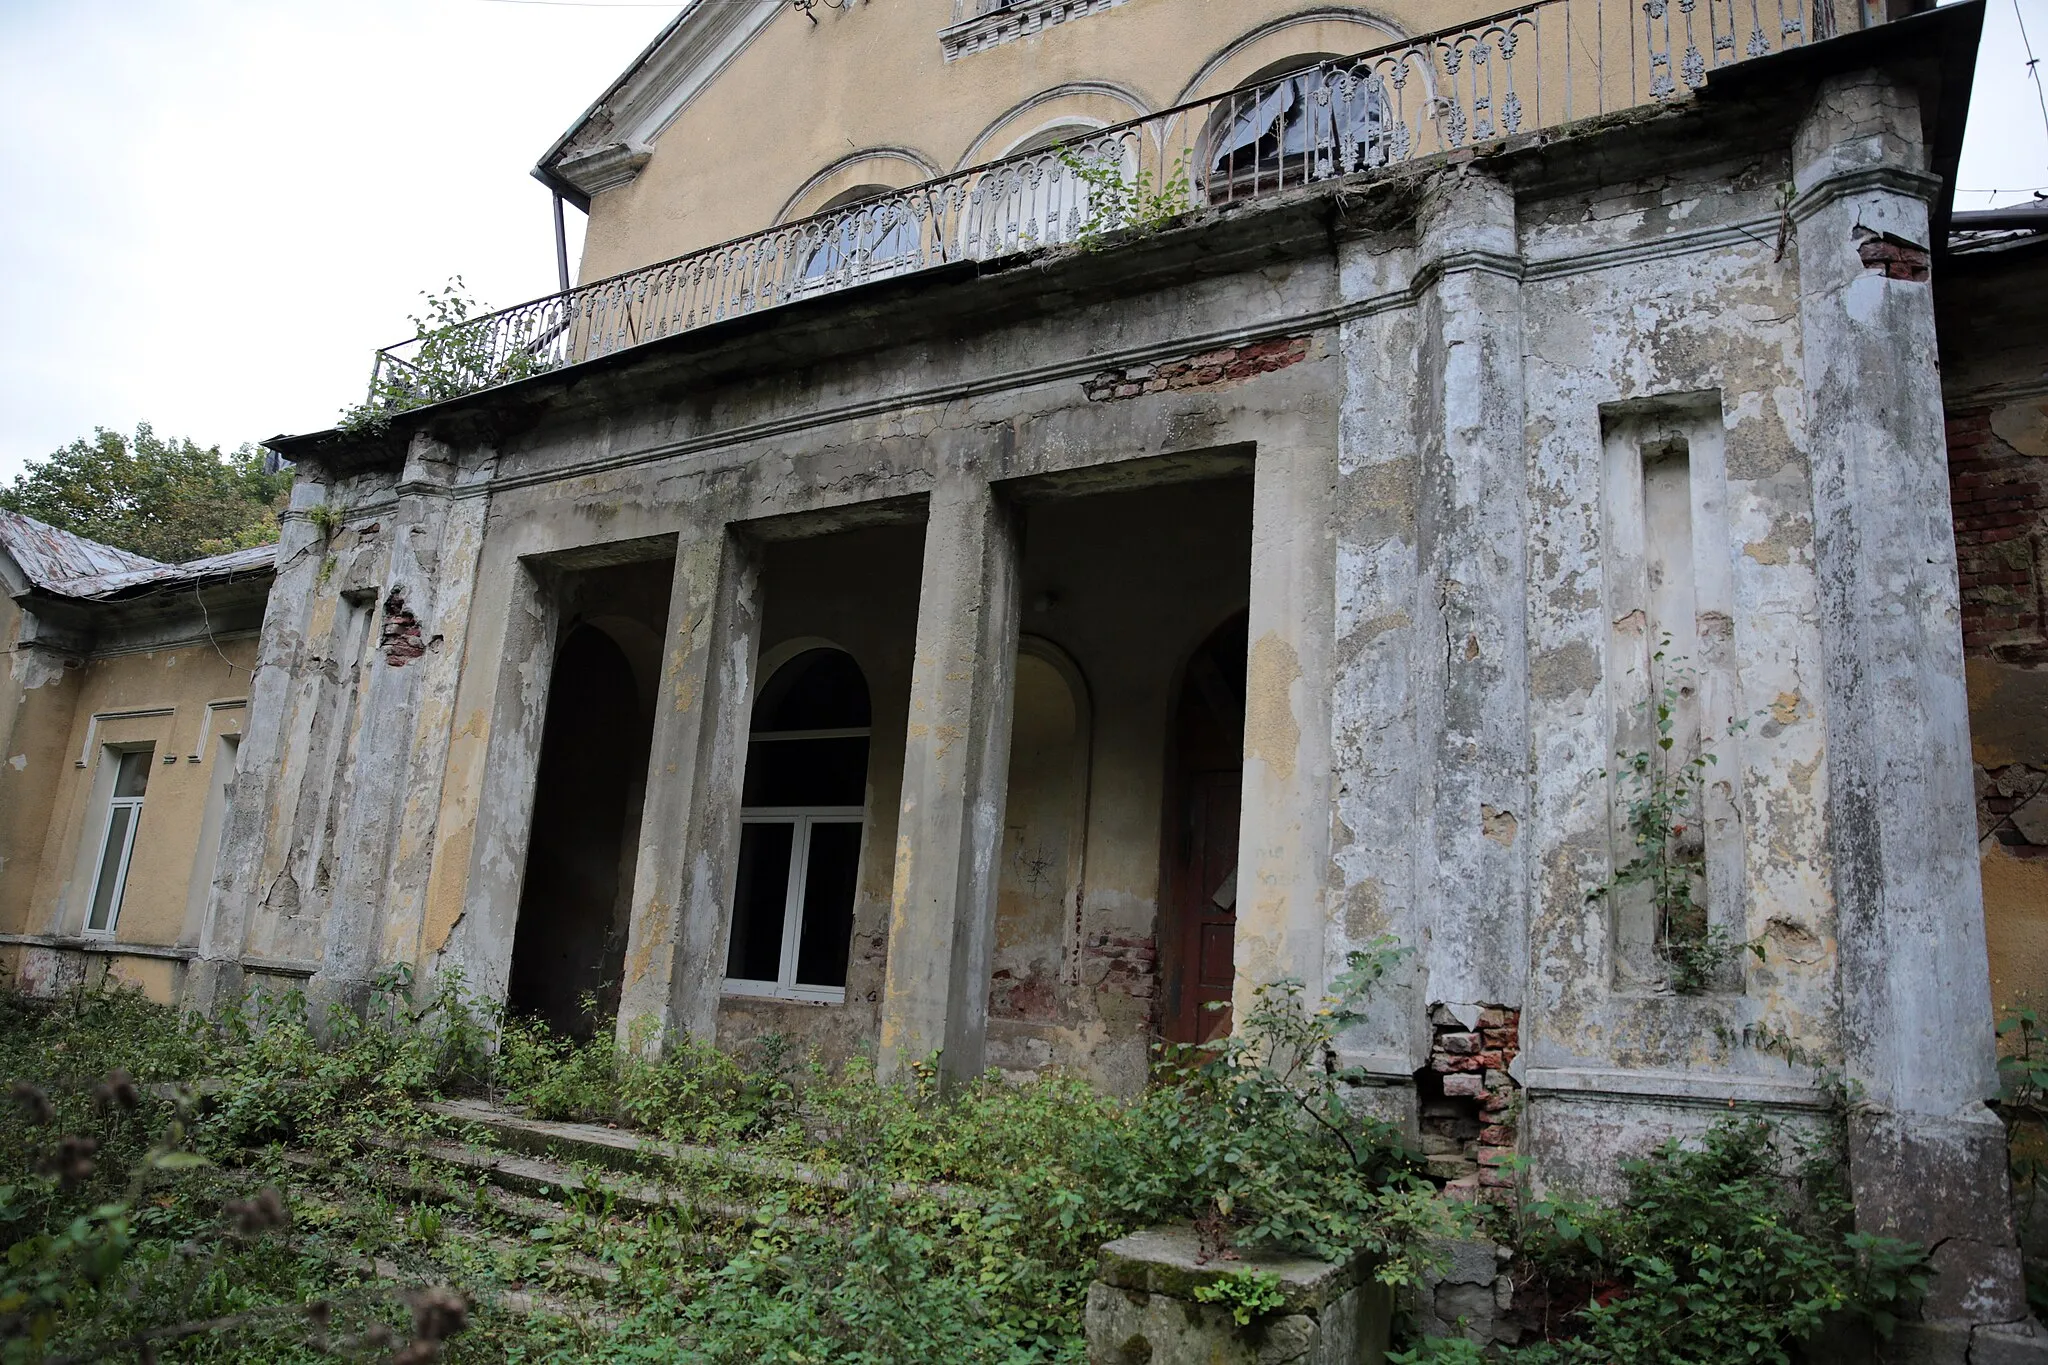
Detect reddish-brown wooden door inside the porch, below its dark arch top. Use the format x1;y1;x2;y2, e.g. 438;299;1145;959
1167;767;1243;1044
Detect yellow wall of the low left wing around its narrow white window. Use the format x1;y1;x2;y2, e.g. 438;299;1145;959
17;636;256;957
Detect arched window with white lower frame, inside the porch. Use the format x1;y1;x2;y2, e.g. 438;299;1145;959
725;649;872;1005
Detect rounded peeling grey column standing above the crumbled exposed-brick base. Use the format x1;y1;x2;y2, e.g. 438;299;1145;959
1411;170;1530;1007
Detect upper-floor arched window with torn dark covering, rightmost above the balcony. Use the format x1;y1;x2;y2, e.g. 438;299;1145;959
1200;53;1386;203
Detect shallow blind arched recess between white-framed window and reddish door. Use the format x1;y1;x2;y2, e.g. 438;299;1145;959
989;634;1094;1023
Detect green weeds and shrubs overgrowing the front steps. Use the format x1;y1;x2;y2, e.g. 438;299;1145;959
0;950;1458;1365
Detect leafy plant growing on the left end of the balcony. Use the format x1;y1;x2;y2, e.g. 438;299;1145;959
340;274;555;432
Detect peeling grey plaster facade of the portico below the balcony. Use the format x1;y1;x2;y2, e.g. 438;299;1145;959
207;42;2009;1312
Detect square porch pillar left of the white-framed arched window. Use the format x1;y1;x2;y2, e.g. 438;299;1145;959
618;520;760;1044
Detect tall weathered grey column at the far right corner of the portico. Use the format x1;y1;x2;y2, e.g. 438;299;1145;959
1792;72;2025;1334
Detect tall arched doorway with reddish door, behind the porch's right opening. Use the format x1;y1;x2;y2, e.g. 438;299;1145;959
1159;612;1245;1044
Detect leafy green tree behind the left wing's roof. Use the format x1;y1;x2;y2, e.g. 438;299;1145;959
0;422;291;563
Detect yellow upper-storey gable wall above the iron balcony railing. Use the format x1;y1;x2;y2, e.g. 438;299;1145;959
580;0;1855;280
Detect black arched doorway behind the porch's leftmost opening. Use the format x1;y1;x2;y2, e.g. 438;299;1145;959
506;624;653;1038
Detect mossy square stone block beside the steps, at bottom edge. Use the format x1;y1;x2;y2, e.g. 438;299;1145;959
1085;1228;1393;1365
